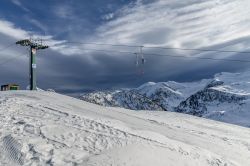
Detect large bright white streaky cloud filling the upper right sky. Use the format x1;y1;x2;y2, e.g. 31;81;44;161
89;0;250;52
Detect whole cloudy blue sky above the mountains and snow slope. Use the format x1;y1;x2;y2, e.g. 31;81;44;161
0;0;250;95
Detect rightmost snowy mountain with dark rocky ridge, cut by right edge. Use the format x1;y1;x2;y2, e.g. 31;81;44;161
175;72;250;127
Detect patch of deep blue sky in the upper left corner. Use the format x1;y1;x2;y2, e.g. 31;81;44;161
0;0;132;39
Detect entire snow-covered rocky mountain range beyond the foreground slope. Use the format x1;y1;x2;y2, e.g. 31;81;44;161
81;71;250;127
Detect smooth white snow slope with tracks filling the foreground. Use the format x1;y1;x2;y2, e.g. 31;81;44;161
0;91;250;166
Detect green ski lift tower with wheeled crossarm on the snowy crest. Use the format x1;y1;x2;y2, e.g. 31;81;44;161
16;39;49;90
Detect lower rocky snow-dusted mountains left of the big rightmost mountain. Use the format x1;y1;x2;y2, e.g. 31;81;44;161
81;80;208;111
